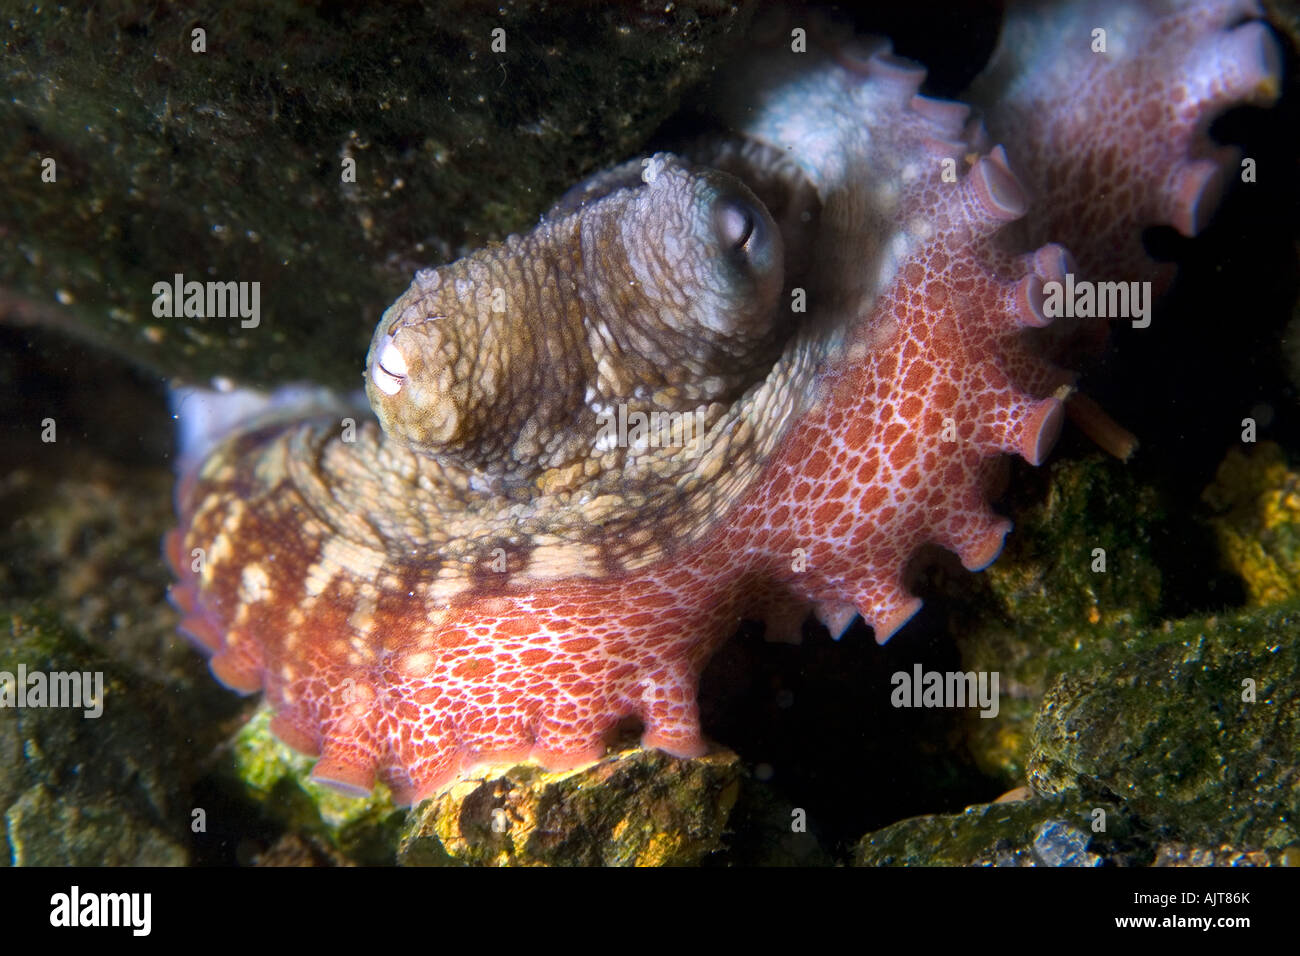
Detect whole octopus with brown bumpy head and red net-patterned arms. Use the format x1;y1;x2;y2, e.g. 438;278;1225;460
168;3;1278;801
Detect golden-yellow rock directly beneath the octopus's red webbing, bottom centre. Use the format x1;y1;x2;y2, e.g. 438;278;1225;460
398;747;744;866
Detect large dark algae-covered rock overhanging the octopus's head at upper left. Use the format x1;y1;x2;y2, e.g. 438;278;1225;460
0;0;748;388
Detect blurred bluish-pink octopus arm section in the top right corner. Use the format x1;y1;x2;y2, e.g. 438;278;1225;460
967;0;1281;287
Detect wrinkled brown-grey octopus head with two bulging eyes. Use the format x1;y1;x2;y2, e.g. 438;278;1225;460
367;153;784;480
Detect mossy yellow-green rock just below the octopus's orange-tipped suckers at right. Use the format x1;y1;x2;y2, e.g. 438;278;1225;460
949;453;1166;788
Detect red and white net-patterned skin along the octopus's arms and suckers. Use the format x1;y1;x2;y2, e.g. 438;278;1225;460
168;3;1277;803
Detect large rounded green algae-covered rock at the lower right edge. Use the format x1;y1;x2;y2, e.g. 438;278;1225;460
1030;604;1300;849
